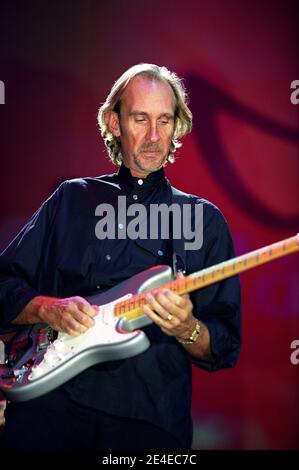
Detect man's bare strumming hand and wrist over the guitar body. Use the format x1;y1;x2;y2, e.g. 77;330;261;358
12;296;98;336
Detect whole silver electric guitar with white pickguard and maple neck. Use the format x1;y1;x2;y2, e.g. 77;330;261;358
0;234;299;402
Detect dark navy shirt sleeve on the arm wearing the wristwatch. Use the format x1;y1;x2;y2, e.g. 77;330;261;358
188;212;241;372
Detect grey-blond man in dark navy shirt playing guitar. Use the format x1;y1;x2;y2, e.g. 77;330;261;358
0;64;240;450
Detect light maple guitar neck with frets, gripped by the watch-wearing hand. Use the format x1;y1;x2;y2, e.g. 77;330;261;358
114;234;299;320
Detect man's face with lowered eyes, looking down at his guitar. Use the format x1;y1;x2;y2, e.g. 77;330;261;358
110;76;175;178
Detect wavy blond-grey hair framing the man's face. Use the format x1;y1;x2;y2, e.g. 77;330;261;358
98;63;192;165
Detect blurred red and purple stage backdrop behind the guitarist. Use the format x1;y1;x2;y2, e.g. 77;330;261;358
0;0;299;449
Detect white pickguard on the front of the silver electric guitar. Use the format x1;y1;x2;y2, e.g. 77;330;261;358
28;294;134;381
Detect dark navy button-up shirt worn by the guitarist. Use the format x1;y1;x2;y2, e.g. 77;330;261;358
0;166;240;443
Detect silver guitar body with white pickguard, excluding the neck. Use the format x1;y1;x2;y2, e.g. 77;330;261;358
0;266;173;402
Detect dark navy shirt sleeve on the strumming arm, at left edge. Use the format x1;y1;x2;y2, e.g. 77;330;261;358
0;185;63;331
